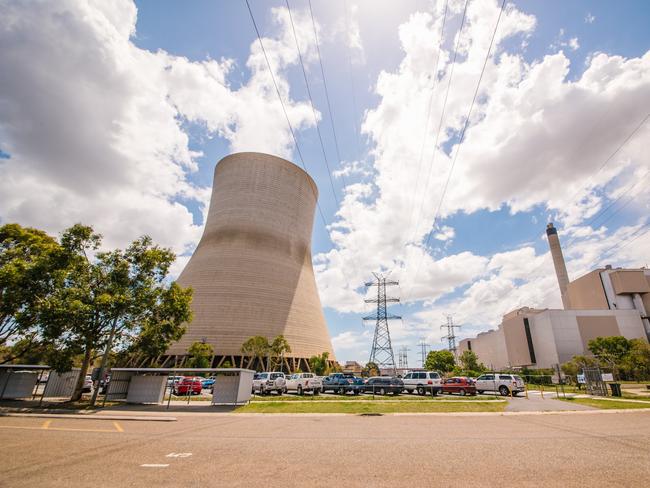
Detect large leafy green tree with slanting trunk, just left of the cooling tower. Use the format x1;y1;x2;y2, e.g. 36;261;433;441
41;224;191;401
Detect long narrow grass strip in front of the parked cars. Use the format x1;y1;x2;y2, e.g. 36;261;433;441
235;401;507;414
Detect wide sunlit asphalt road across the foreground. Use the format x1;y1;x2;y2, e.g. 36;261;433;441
0;412;650;488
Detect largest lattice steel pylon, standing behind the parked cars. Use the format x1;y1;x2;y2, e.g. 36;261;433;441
363;273;402;374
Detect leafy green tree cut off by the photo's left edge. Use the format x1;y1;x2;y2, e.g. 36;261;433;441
0;224;67;364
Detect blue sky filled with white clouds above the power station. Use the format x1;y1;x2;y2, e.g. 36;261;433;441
0;0;650;366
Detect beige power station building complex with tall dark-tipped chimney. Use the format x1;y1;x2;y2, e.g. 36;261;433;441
458;224;650;369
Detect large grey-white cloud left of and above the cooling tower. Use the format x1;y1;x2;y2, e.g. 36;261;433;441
0;0;313;253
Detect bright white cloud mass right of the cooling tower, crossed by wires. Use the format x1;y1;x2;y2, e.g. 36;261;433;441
317;2;650;336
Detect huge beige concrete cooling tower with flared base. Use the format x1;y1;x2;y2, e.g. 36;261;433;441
166;153;334;371
